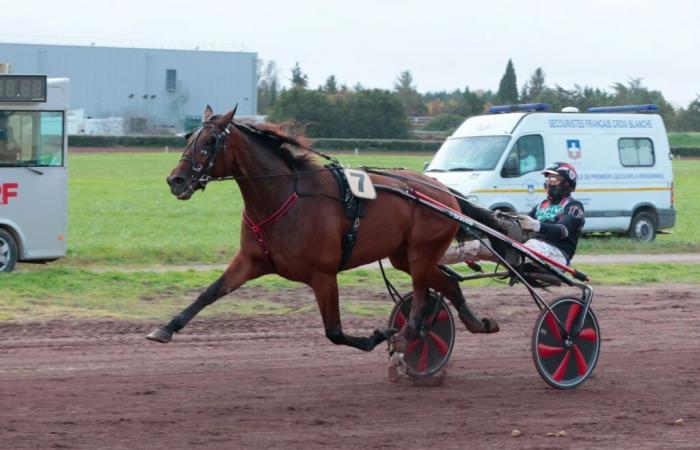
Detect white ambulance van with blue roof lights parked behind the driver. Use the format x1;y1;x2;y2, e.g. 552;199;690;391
425;103;676;240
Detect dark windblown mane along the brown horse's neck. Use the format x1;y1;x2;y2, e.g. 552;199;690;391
233;122;316;169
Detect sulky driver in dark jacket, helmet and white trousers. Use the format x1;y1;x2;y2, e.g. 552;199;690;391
438;162;585;265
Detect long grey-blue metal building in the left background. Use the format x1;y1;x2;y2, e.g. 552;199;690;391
0;43;257;131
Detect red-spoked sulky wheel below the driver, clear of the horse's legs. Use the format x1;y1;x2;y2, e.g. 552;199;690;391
532;297;600;389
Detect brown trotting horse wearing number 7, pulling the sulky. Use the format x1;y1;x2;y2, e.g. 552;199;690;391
147;106;498;351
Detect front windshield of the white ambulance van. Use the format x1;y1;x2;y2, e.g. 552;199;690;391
425;136;510;172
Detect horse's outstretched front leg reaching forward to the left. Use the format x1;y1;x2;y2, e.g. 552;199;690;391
146;252;269;344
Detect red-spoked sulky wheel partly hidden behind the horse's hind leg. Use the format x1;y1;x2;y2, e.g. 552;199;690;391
389;291;455;377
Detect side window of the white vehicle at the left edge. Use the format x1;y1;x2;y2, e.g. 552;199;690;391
0;111;63;167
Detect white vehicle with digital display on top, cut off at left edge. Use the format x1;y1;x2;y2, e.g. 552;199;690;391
0;74;70;272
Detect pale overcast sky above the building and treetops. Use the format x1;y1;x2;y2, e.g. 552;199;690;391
0;0;700;107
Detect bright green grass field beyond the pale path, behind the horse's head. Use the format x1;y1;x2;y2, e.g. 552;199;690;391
59;153;700;266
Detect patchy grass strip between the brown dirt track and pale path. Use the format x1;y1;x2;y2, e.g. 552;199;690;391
0;264;700;327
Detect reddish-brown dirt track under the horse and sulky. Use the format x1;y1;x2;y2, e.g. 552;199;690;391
0;285;700;449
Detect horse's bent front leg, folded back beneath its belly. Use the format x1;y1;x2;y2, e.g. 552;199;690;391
309;274;392;352
